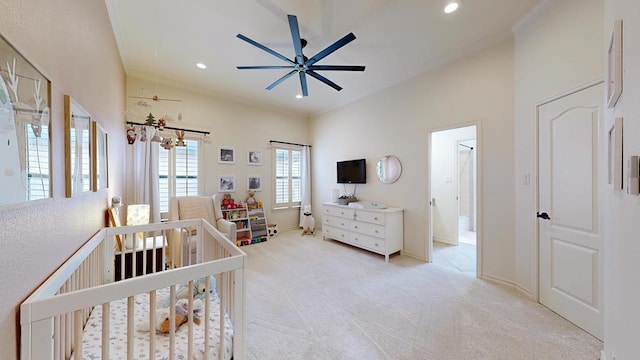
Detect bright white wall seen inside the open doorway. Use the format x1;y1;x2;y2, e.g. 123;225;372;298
431;126;476;245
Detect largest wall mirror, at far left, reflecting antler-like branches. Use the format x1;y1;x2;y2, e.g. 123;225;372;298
0;36;51;207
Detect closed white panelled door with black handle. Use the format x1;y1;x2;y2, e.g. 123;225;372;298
538;83;604;339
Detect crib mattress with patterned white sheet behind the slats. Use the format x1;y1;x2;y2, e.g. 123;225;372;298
75;289;233;360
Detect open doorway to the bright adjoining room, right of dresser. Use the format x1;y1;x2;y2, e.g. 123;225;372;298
428;125;478;275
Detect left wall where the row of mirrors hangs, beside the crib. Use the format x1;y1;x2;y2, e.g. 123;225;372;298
0;0;124;359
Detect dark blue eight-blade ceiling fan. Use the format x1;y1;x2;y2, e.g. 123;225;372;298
237;15;365;96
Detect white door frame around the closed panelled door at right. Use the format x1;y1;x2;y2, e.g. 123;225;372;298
531;77;606;303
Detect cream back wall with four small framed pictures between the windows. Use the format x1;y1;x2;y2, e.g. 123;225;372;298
127;77;315;230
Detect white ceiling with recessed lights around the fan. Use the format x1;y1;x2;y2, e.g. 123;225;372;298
105;0;539;114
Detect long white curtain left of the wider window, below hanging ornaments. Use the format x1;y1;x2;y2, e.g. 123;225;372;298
130;126;160;222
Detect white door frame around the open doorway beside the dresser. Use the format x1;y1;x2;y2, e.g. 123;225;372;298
424;118;483;278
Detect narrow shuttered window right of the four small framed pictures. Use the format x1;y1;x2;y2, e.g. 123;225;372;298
273;147;302;209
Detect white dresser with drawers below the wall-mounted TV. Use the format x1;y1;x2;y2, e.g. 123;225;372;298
322;203;404;262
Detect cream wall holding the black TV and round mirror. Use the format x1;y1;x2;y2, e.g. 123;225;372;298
311;41;514;282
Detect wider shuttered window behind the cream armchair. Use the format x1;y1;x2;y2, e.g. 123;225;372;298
158;139;200;214
